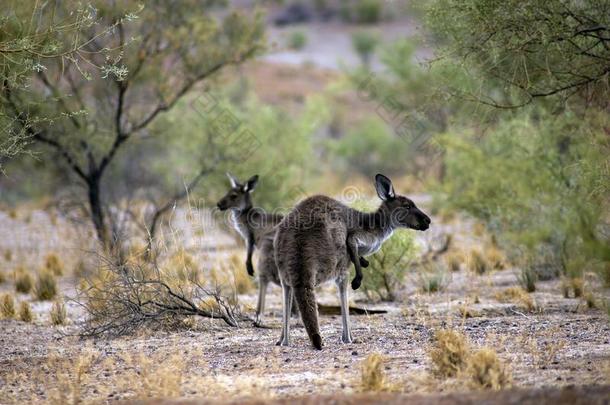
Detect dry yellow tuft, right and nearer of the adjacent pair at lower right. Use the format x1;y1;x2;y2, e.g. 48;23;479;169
465;348;512;390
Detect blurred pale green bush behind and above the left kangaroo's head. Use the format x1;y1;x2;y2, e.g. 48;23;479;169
152;94;325;210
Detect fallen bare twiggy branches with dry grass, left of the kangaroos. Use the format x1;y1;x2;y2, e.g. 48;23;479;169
77;252;249;336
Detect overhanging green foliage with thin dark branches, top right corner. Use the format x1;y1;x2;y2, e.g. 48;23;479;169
427;0;610;105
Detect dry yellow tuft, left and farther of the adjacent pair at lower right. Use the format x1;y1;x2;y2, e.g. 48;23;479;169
429;329;470;377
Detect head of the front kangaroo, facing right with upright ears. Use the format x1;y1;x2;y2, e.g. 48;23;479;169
375;174;431;231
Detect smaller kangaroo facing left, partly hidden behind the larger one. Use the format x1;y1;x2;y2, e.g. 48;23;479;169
216;173;368;326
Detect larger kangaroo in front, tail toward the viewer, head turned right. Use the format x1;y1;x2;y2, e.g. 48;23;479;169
274;174;431;350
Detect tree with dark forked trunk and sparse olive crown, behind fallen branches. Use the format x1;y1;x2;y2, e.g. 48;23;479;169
1;0;263;248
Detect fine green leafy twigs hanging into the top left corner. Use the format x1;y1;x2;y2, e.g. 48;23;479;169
0;1;132;169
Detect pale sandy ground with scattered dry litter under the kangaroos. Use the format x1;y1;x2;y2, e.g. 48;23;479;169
0;205;610;404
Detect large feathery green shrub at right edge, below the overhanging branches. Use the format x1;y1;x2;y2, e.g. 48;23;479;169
443;110;610;271
